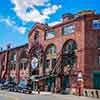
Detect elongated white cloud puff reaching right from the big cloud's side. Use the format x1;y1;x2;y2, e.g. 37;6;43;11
43;5;61;15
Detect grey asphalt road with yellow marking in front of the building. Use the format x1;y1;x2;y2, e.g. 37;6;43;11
0;91;100;100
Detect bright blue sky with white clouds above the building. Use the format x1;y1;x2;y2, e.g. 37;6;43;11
0;0;100;49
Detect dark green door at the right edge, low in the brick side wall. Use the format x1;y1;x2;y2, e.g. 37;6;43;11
93;72;100;89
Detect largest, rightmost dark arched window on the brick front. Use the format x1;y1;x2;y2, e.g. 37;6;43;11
63;40;77;66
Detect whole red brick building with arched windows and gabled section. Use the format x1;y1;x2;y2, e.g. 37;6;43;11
0;10;100;92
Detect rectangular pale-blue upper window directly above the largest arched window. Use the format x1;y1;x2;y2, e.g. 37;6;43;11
63;25;75;35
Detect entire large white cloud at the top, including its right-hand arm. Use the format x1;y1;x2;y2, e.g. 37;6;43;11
11;0;61;23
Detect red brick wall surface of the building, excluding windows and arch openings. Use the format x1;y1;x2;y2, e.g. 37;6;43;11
0;11;100;94
